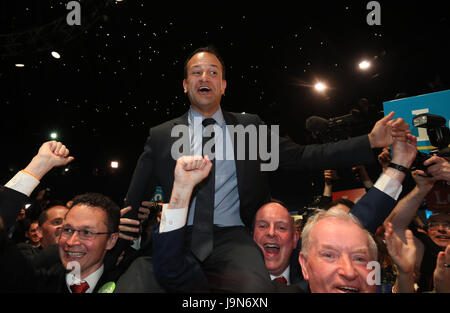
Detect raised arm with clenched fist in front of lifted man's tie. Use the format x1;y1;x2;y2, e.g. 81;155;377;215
152;156;212;292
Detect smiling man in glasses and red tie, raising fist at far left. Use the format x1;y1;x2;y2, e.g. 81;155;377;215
0;141;120;292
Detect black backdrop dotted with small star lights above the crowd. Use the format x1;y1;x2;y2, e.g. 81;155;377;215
0;0;448;202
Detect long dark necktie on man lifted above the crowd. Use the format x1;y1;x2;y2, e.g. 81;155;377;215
191;118;216;262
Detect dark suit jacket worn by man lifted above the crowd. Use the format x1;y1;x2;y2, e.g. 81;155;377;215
126;111;375;227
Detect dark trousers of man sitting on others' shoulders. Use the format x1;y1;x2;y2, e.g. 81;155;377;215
186;226;274;293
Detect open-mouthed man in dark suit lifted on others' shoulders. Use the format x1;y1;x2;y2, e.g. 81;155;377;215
126;47;407;292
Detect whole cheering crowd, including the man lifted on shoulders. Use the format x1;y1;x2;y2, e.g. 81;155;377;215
0;47;450;293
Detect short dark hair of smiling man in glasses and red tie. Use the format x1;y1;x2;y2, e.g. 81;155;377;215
69;193;120;233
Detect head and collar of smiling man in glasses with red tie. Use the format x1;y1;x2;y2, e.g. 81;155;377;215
58;193;120;292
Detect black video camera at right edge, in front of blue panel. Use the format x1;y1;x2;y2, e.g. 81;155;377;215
411;113;450;172
